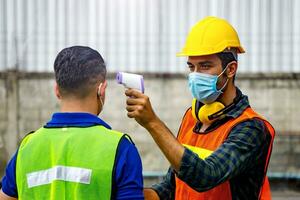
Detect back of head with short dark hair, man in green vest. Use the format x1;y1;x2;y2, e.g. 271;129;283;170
54;46;106;99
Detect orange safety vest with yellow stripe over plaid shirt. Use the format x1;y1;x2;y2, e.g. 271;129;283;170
175;107;275;200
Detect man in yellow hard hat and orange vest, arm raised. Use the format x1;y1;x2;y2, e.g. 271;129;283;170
125;17;274;200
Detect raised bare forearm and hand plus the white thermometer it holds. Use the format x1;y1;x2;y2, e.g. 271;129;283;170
117;72;184;172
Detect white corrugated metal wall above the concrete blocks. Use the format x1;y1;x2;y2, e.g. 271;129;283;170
0;0;300;73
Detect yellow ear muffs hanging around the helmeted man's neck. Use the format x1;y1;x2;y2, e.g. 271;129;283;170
192;98;225;124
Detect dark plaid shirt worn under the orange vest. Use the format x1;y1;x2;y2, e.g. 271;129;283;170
152;89;271;200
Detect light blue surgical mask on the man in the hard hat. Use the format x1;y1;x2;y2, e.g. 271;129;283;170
189;67;228;104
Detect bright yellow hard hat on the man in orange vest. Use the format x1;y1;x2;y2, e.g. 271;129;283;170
177;16;245;56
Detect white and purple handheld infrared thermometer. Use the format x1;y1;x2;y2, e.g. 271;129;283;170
116;72;145;93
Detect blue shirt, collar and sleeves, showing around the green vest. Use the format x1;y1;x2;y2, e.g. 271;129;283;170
2;113;144;200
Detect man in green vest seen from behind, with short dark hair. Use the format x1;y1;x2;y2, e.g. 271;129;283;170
0;46;144;200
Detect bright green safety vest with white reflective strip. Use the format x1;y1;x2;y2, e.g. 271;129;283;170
16;126;124;200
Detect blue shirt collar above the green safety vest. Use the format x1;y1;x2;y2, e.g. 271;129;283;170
44;112;111;129
